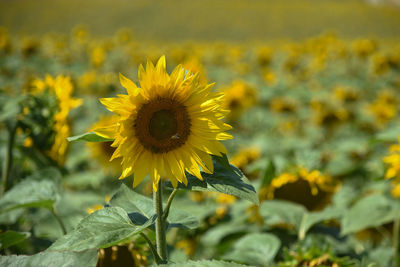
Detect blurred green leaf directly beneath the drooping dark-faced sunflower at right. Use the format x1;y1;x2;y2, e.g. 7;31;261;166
260;200;307;230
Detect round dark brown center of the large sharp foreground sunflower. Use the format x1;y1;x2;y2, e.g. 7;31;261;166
134;98;191;153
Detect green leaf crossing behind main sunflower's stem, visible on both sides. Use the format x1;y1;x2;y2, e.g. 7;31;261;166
110;184;199;229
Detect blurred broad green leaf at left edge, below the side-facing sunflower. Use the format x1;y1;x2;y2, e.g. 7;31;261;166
0;179;59;211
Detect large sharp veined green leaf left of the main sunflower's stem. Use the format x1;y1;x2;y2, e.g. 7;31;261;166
48;207;155;251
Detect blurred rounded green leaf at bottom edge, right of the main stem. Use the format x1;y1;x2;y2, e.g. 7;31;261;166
223;233;281;266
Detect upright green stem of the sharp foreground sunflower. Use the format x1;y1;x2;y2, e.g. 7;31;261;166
153;181;167;262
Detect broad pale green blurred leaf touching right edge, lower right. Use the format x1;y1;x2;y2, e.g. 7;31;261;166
341;194;400;235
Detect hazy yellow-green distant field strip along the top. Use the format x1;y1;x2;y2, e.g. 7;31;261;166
0;0;400;42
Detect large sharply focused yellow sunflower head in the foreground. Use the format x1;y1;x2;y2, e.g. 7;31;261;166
95;56;232;191
